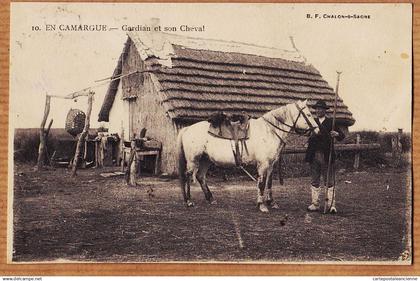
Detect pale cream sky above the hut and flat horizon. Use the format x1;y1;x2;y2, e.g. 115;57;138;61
9;3;412;131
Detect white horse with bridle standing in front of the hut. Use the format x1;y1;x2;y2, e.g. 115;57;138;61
178;100;319;212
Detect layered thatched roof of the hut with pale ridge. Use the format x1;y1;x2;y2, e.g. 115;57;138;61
100;33;355;126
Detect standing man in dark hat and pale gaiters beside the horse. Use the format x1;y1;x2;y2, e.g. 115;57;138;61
305;101;345;213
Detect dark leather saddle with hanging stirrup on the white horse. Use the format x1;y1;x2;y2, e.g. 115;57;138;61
207;112;249;166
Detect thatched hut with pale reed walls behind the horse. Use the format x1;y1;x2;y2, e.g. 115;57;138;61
99;32;355;172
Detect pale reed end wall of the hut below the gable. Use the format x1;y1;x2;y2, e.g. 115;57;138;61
130;75;177;174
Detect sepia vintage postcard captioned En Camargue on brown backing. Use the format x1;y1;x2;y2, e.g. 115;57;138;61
8;2;413;265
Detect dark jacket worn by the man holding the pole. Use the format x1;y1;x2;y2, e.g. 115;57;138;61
305;118;345;163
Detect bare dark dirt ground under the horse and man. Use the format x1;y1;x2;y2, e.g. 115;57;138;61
13;164;411;262
